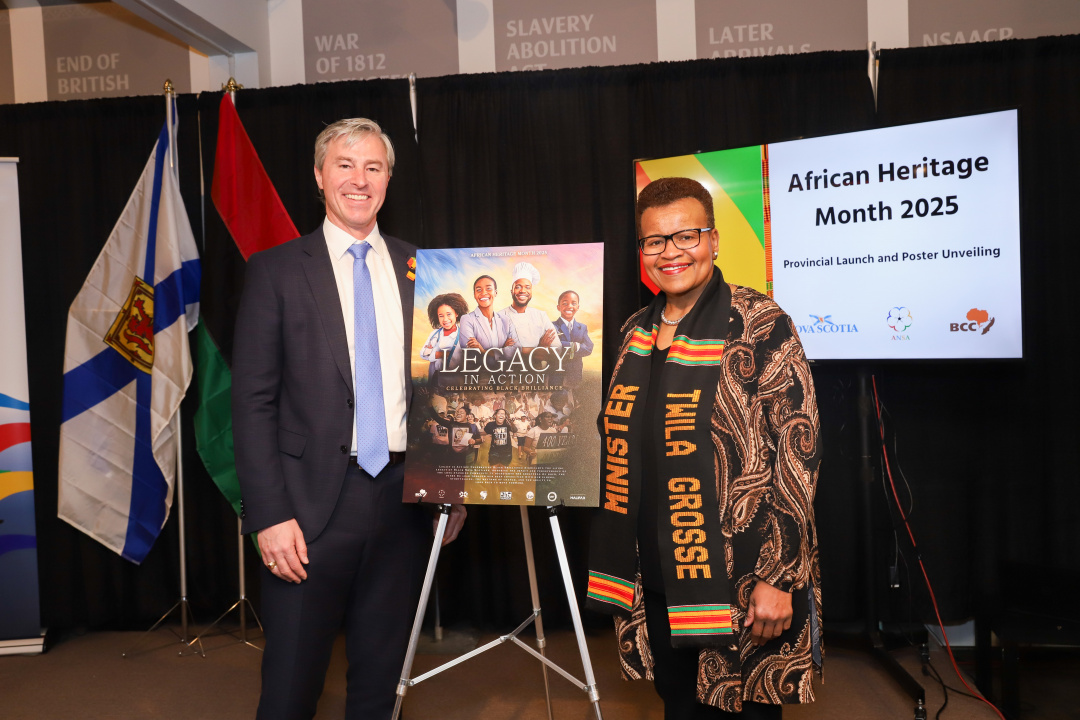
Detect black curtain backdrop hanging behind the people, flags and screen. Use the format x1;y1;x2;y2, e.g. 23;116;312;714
0;38;1080;631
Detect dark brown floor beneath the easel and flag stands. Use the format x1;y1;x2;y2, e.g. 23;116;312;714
0;629;1080;720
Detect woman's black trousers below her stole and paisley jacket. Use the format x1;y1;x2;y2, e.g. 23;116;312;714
645;589;783;720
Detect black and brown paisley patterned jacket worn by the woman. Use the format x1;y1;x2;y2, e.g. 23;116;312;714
612;285;822;712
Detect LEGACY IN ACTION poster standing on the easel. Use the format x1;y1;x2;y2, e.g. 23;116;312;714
403;243;604;507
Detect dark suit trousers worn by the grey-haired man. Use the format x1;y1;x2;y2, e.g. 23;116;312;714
257;463;432;720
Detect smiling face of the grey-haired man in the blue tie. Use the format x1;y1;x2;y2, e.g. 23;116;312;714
315;134;390;240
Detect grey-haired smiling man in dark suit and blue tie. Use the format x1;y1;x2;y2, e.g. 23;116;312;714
232;118;464;720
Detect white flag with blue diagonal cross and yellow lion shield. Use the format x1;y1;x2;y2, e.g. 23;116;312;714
58;120;201;563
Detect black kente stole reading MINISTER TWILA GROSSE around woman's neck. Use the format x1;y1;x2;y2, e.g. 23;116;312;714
586;270;734;648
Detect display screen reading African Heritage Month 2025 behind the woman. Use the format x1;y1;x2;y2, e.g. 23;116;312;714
635;110;1023;359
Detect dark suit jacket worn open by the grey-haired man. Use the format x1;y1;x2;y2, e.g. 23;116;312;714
232;227;416;542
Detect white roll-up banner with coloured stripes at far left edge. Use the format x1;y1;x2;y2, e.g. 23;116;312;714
0;158;42;655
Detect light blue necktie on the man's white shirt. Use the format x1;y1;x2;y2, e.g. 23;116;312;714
349;243;390;477
